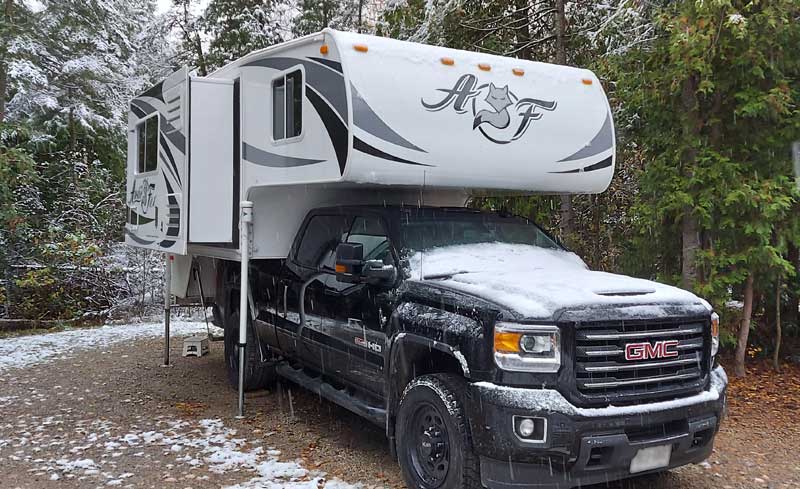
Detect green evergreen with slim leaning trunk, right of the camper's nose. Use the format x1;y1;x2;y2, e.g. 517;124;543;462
617;0;800;375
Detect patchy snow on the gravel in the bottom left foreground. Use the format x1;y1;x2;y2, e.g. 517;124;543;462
0;415;365;489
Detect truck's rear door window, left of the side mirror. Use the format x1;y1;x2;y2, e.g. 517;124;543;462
296;216;353;271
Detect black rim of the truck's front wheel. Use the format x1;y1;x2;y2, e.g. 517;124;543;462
406;403;450;489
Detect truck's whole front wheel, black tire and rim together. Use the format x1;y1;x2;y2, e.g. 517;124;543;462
395;374;482;489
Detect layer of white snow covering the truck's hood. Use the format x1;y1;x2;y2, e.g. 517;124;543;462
409;243;706;319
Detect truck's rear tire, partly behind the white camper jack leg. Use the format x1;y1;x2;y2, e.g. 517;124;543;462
225;311;277;391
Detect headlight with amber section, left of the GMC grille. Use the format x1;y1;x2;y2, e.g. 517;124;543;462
494;323;561;372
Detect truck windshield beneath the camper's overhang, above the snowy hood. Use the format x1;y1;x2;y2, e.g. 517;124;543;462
400;212;561;252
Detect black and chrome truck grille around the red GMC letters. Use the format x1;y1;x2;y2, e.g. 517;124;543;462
575;320;709;404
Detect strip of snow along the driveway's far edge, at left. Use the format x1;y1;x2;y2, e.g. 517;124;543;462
0;321;206;372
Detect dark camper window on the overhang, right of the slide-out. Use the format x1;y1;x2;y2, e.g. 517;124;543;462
272;70;303;141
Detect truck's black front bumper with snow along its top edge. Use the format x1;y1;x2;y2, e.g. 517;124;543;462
466;367;728;489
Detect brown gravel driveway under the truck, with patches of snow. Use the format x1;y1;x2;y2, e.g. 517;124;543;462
0;323;800;489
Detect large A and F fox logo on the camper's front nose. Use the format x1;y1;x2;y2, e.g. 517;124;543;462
420;74;556;144
